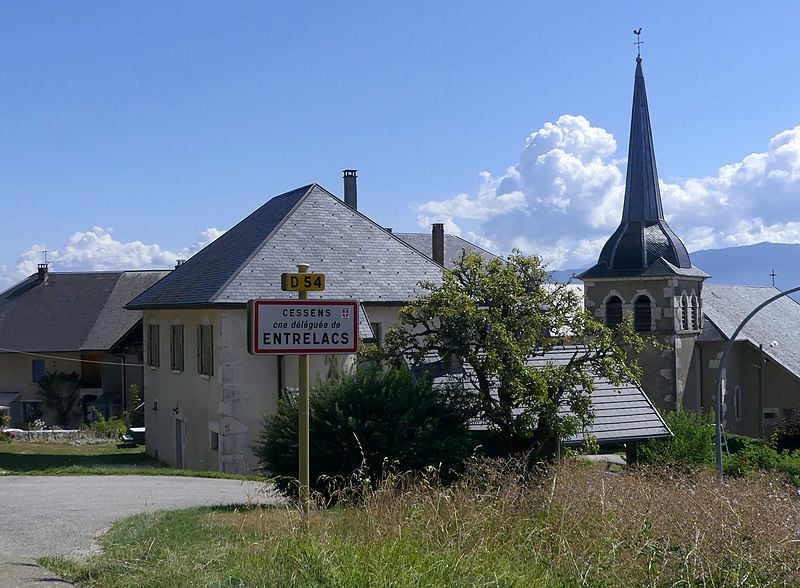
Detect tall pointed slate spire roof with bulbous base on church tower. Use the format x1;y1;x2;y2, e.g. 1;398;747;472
579;57;707;278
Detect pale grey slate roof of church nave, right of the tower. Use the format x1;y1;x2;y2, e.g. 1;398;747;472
699;283;800;377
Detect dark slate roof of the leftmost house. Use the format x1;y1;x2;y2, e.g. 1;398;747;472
0;271;168;352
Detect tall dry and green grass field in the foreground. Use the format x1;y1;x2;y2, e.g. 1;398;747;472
44;462;800;588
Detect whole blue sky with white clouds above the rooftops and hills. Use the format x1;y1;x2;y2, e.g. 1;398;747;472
0;0;800;289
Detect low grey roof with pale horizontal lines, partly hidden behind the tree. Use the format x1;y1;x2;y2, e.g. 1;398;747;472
433;346;672;445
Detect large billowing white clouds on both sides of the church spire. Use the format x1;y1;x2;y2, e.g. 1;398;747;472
416;115;800;268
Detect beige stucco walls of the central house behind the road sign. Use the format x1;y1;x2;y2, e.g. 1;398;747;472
144;306;406;473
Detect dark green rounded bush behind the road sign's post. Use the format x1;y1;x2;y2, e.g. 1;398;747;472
253;366;472;498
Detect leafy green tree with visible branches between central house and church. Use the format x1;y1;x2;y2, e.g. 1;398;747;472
368;251;644;454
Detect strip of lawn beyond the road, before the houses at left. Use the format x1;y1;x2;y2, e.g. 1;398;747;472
0;438;253;480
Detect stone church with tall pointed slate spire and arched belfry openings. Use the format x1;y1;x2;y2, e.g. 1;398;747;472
578;55;800;437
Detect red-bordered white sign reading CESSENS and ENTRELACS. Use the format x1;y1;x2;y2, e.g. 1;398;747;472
247;300;358;355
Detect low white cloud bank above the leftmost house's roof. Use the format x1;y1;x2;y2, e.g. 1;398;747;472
0;227;223;286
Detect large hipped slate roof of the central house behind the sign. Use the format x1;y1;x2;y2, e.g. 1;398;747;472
128;184;442;309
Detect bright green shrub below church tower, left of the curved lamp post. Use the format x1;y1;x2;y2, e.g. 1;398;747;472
637;409;715;465
